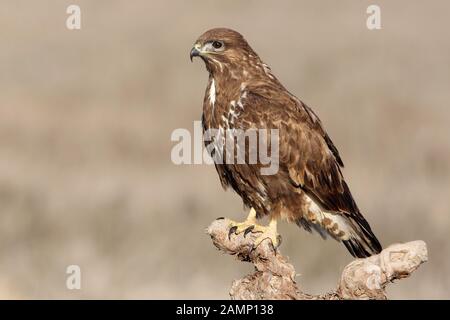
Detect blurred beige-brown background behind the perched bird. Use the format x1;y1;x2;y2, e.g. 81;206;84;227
0;0;450;299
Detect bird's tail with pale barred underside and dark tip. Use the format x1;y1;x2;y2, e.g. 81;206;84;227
296;212;382;258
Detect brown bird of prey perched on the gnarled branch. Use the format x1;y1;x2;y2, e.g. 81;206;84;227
190;28;382;257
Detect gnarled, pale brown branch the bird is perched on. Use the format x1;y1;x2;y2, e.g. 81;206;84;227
207;218;428;300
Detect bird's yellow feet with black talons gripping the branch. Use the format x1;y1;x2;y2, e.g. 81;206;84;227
228;208;281;249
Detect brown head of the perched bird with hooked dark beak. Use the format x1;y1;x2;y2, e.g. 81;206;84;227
190;28;257;72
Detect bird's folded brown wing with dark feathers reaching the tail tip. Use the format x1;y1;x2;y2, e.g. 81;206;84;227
241;85;381;257
